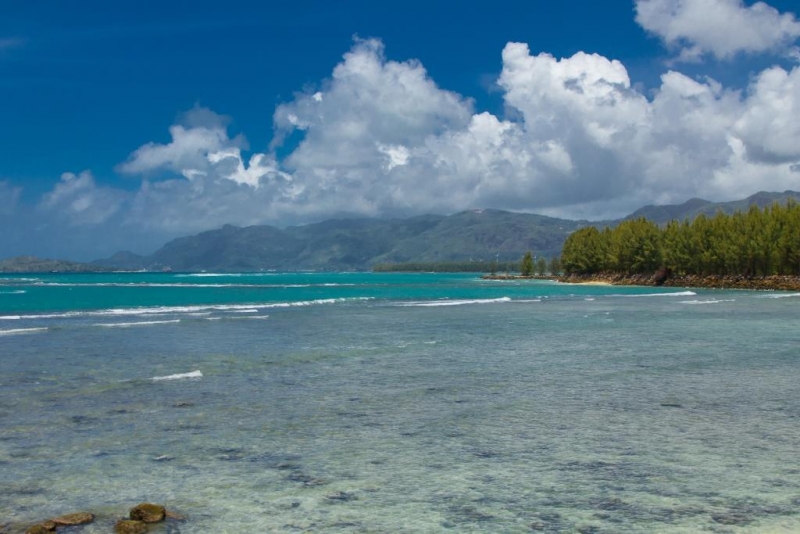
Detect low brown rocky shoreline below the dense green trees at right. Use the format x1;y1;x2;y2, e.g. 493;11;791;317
482;271;800;291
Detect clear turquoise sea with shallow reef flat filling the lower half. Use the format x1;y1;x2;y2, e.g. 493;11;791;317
0;273;800;533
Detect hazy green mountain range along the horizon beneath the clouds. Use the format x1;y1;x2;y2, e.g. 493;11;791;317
0;191;800;272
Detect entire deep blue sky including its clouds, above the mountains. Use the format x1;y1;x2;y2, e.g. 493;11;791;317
0;0;800;260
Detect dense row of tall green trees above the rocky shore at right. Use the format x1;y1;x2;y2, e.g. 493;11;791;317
561;200;800;276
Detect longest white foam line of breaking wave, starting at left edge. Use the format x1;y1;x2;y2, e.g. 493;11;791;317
0;297;373;319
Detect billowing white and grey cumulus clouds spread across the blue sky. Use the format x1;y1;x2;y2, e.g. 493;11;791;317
7;0;800;260
